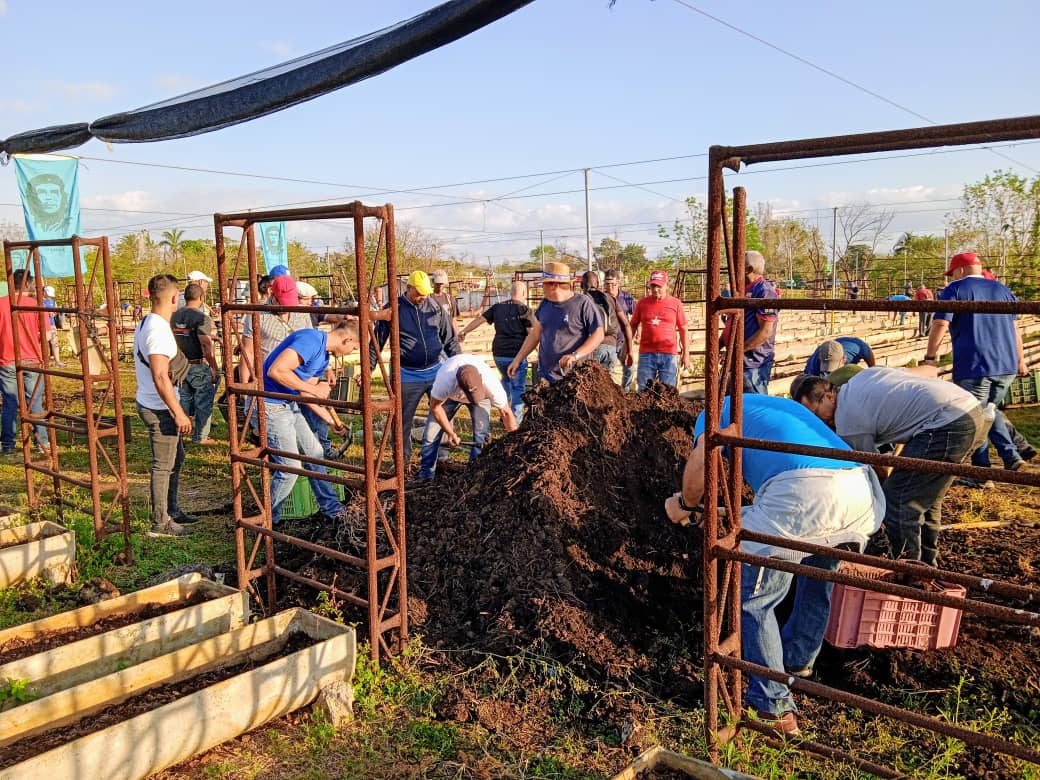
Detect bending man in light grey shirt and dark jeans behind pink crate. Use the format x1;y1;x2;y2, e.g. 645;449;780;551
790;366;989;566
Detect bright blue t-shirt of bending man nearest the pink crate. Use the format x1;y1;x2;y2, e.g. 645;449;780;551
694;393;859;493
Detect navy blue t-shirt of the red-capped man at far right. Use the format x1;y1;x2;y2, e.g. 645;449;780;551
935;277;1018;382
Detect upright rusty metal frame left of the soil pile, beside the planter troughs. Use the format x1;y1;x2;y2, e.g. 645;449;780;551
213;202;408;660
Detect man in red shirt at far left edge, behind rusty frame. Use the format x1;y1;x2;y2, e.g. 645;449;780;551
0;268;50;457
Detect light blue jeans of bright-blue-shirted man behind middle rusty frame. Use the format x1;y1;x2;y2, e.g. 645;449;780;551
264;400;343;523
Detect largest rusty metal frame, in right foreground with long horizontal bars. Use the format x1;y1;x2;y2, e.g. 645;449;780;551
703;116;1040;777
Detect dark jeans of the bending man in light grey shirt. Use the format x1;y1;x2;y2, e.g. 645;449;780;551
883;410;985;566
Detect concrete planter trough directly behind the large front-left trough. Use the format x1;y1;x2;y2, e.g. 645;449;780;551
0;574;250;697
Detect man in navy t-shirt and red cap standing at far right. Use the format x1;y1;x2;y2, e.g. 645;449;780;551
922;252;1029;476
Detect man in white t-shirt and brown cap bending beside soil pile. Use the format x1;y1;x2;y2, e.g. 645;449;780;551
409;355;517;480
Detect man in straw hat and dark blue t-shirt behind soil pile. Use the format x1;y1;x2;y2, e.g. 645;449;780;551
505;262;603;383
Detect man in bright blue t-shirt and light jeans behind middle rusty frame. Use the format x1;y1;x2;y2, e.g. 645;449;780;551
263;321;359;523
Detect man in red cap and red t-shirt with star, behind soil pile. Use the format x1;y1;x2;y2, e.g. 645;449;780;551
631;270;690;390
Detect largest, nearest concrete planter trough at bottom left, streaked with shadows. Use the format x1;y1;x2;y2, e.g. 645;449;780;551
0;609;357;780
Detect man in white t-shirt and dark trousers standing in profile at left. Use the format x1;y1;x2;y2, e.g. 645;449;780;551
133;274;196;537
